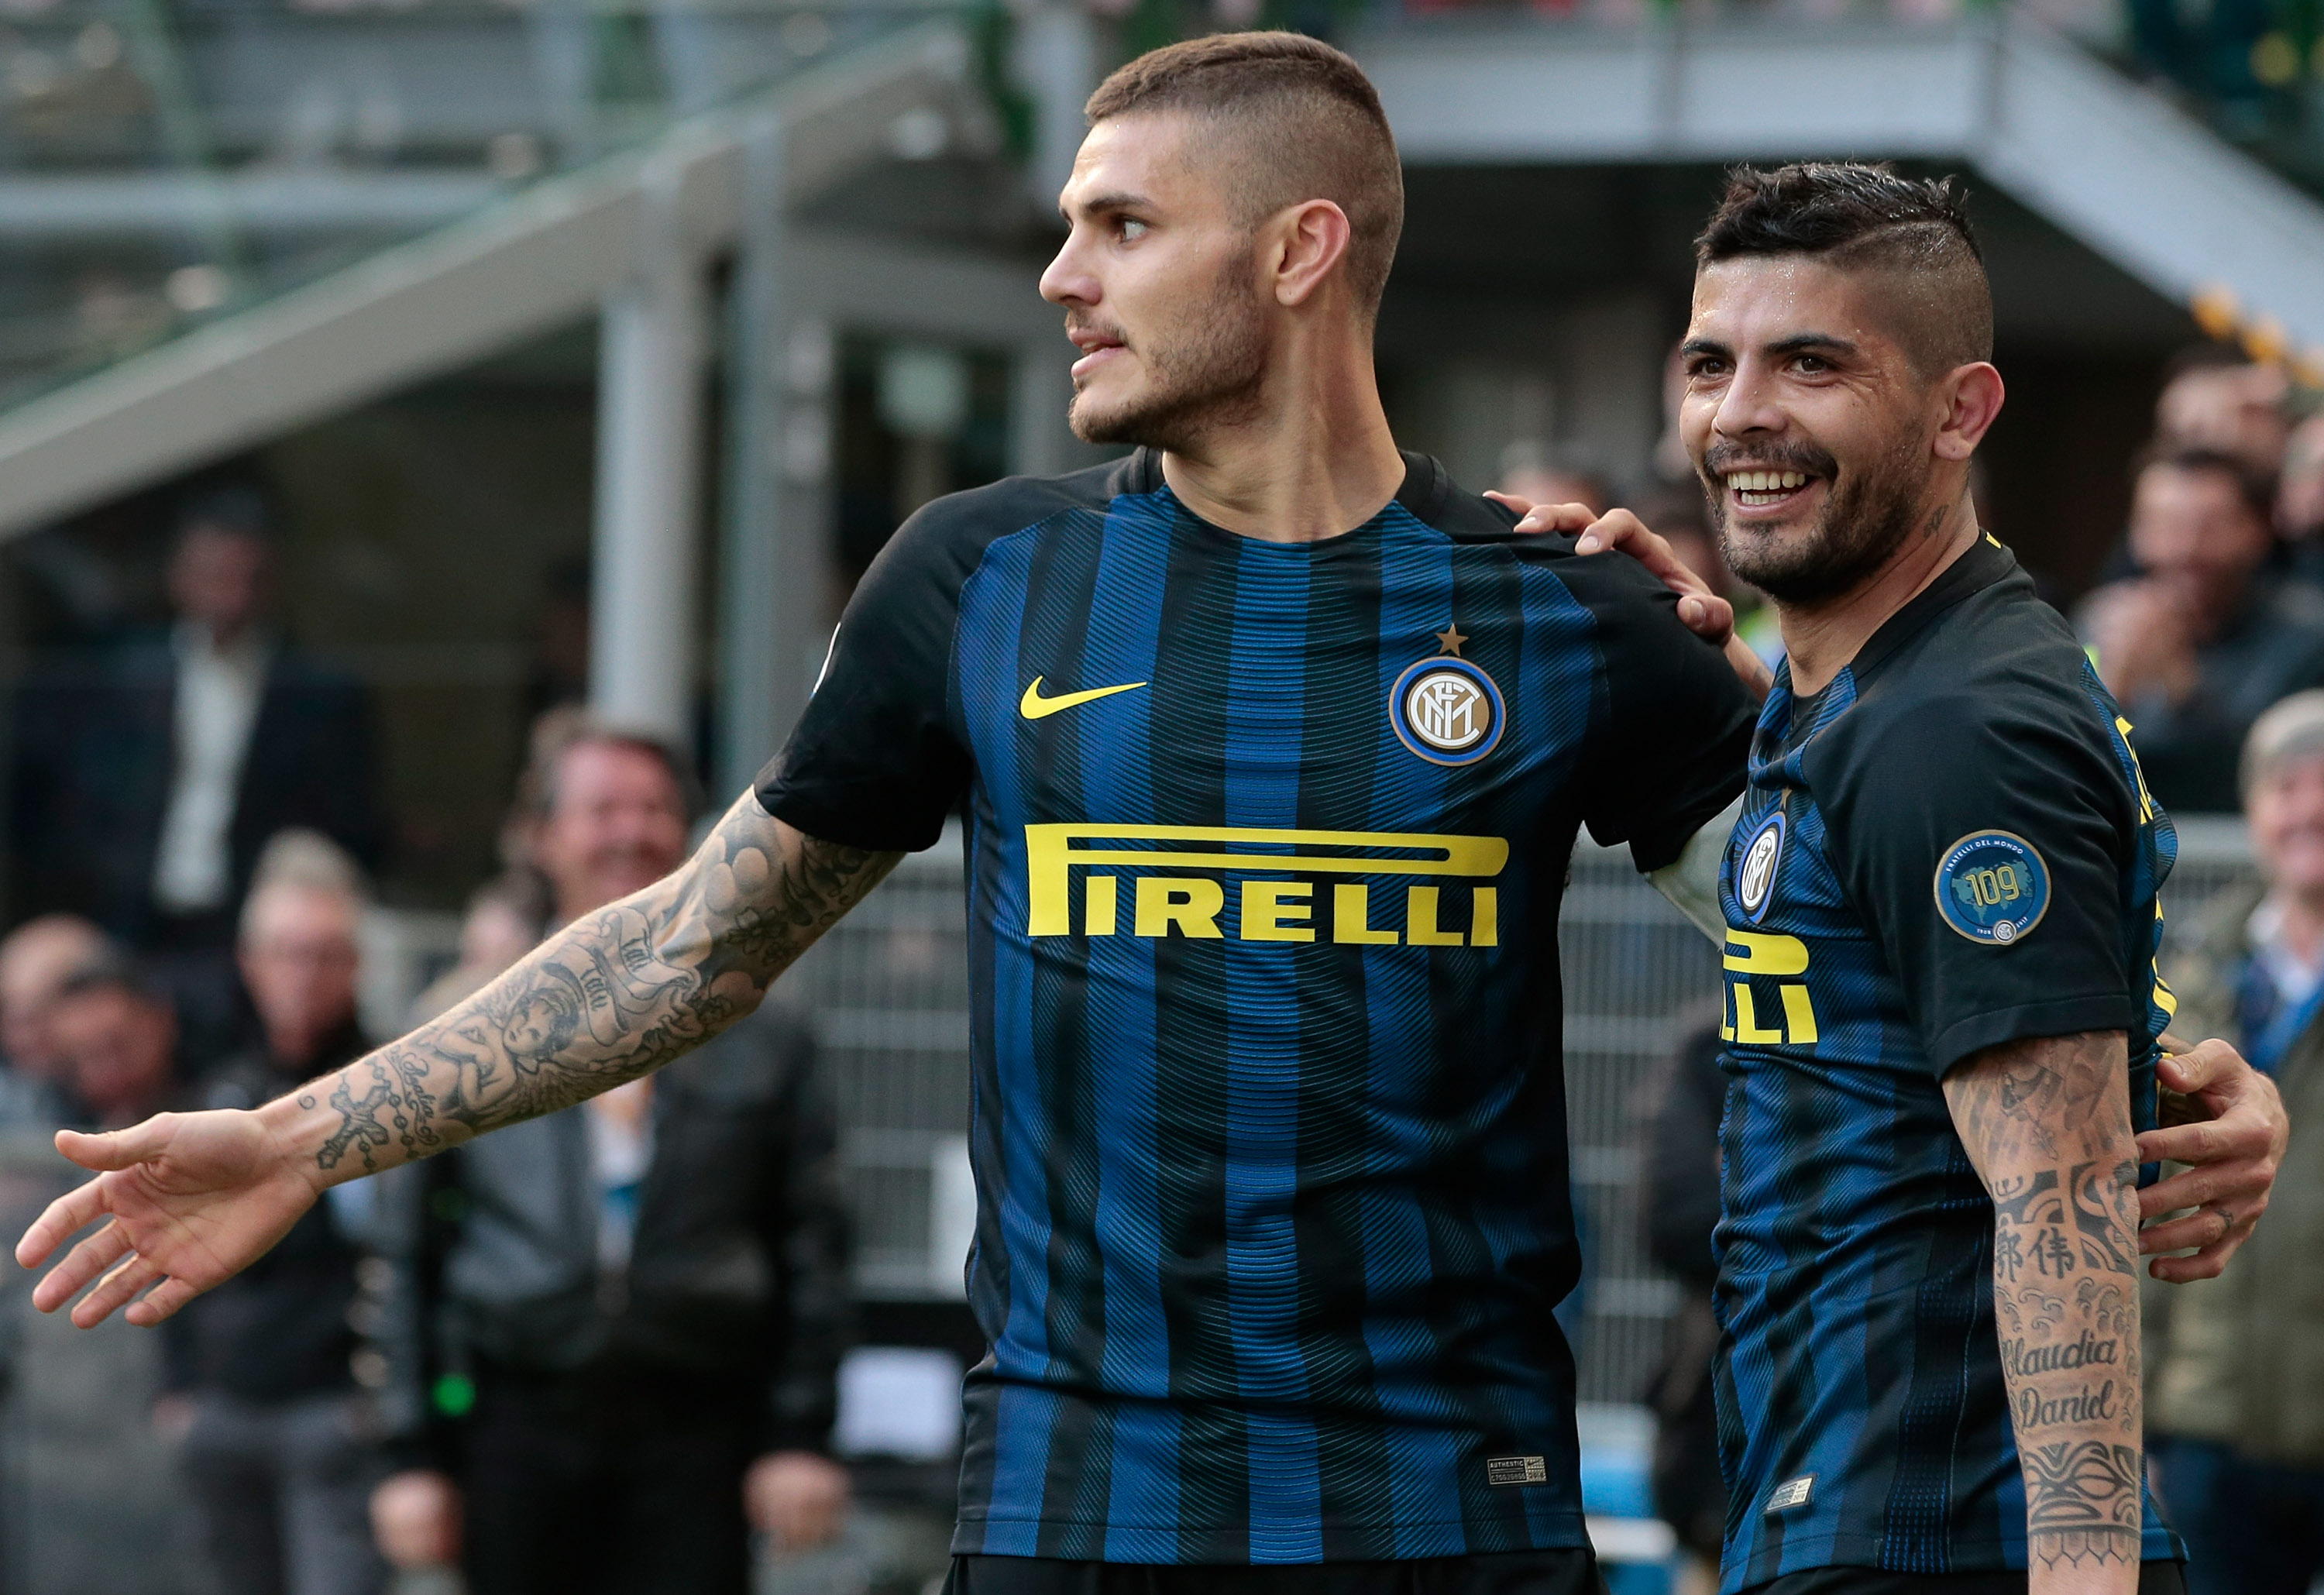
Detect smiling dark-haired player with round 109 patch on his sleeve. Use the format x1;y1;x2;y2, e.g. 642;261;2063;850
1529;165;2280;1595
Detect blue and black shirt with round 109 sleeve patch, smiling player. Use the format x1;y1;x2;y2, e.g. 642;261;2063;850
1717;537;2185;1590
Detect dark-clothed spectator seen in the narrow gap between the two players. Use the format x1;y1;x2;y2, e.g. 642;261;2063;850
1643;1026;1727;1590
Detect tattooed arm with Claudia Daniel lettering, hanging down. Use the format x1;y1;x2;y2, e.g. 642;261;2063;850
1945;1030;2143;1595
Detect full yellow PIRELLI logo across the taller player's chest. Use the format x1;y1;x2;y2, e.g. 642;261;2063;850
1025;826;1508;947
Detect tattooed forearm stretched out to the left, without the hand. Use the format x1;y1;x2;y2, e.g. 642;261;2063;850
297;792;902;1174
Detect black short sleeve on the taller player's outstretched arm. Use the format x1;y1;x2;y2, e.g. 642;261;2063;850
758;500;974;854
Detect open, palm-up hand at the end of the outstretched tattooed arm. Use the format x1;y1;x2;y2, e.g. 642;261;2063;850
16;1112;323;1330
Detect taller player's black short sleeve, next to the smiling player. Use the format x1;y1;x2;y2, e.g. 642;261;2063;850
1576;553;1757;872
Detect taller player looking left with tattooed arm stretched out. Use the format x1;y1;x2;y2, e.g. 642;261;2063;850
28;33;1755;1595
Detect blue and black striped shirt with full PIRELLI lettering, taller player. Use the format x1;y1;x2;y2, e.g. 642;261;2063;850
758;453;1752;1562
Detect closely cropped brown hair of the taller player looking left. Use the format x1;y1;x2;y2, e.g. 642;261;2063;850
1085;33;1404;316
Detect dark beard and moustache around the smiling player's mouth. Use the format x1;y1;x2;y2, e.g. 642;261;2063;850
1699;437;1934;609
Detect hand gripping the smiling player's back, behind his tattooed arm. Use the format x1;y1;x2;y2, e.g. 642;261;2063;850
2138;1035;2291;1284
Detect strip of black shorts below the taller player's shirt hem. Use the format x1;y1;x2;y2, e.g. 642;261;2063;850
944;1551;1606;1595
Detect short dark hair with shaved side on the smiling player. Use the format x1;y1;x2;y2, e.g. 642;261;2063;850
1694;160;1994;376
